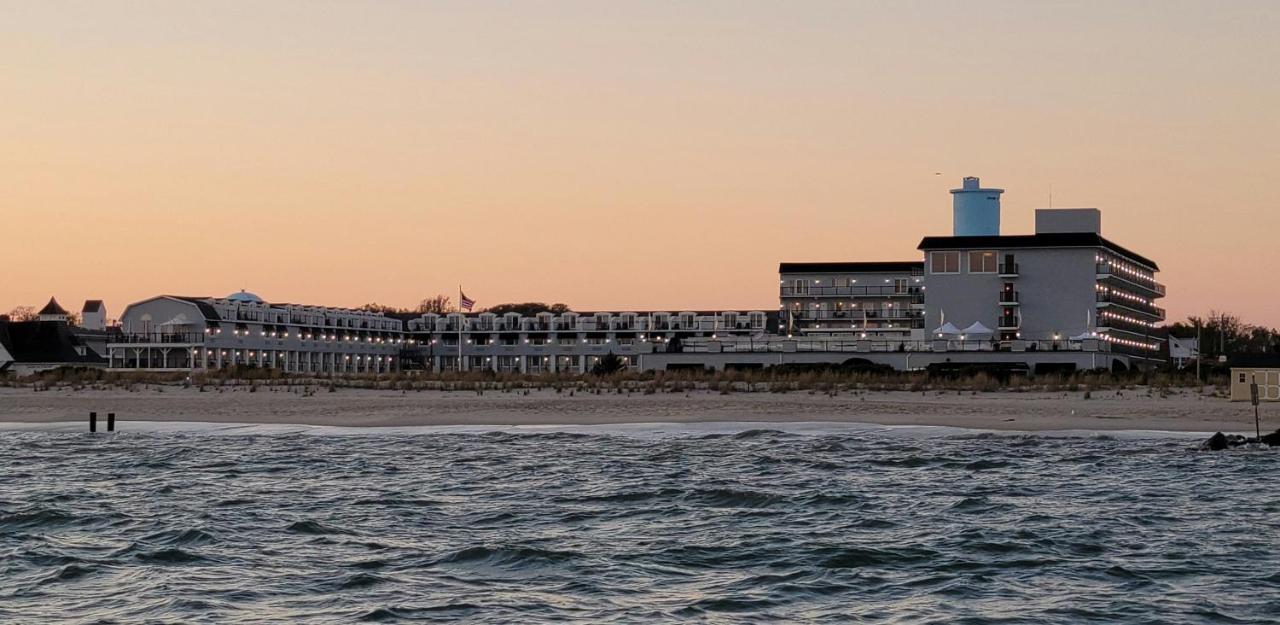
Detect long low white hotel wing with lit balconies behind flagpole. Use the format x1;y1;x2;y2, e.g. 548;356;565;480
106;291;778;375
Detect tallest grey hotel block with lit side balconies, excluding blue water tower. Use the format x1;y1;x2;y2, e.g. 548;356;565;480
920;209;1165;359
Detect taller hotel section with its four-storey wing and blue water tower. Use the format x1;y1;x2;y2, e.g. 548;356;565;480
747;178;1165;368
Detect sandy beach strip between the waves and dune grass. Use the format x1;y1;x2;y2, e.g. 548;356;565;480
0;387;1259;432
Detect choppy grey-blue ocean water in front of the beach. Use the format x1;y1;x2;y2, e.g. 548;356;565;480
0;424;1280;624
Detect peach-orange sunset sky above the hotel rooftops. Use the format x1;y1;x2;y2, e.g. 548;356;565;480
0;0;1280;325
